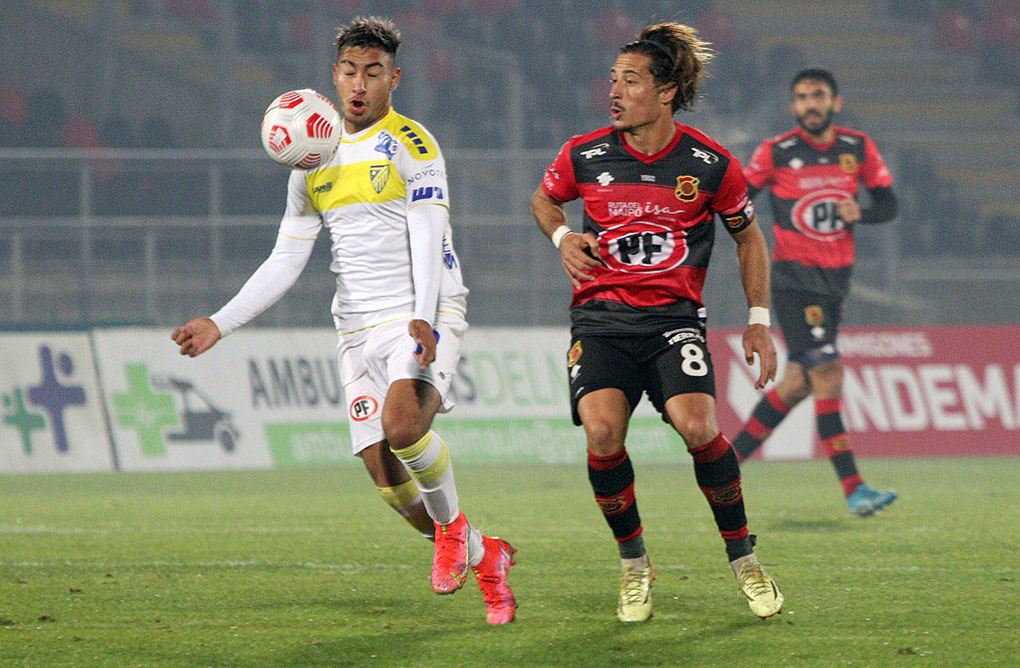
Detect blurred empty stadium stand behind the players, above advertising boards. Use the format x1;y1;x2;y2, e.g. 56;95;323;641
0;0;1020;324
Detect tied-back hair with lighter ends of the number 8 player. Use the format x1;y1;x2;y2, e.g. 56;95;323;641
620;22;713;113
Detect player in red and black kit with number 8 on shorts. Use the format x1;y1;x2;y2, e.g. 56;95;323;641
531;23;782;622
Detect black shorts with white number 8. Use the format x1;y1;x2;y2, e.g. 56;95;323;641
567;323;715;425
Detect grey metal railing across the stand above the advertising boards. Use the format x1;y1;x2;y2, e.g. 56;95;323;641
0;149;1020;327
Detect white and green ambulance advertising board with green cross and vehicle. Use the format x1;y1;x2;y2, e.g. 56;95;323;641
95;327;683;471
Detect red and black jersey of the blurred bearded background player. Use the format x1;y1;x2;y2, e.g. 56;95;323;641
744;125;893;297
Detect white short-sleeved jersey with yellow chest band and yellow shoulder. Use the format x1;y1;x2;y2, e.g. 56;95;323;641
279;109;467;333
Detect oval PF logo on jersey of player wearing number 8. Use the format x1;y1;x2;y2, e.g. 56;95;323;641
599;220;689;273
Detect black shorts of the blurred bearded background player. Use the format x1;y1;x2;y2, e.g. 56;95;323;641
772;291;843;369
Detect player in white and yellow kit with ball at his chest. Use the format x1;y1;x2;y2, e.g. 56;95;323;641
172;16;517;624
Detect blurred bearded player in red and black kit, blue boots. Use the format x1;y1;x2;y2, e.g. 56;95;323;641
733;68;897;517
